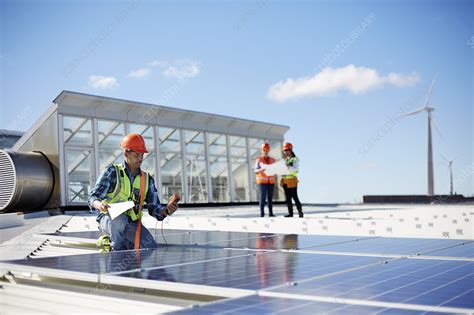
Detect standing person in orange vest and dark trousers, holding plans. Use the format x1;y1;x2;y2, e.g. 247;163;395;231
255;142;275;217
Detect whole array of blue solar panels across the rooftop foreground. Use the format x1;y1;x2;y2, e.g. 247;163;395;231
3;230;474;315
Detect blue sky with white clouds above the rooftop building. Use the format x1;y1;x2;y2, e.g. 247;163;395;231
0;0;474;202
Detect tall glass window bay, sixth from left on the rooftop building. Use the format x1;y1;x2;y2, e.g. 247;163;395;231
209;133;230;202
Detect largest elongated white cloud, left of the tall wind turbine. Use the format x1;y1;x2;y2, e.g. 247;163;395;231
267;65;420;102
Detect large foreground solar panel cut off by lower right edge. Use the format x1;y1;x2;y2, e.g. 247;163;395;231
266;259;474;308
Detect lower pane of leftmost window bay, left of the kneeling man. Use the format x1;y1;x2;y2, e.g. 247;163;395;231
66;150;94;202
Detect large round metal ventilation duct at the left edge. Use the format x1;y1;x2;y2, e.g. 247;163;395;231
0;150;54;212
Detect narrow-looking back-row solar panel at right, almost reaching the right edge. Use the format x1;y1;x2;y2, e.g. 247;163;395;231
302;237;463;255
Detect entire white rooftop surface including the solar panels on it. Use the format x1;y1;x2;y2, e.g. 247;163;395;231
0;205;474;314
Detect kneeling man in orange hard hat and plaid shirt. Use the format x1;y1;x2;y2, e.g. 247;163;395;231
88;133;178;251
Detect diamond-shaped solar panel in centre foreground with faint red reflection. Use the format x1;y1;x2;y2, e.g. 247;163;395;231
115;251;381;290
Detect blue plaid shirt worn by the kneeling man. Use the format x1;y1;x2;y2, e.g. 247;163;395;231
87;161;166;222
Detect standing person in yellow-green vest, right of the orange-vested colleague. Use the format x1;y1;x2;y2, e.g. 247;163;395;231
280;142;303;218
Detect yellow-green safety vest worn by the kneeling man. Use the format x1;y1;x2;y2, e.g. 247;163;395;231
106;163;149;221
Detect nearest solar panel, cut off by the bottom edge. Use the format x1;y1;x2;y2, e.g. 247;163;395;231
169;295;426;315
